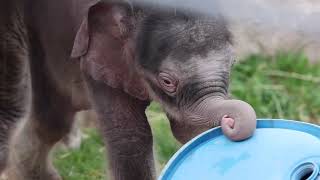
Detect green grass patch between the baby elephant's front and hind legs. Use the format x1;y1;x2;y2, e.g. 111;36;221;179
54;129;106;180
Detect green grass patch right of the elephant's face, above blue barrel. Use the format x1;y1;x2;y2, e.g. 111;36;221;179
230;53;320;123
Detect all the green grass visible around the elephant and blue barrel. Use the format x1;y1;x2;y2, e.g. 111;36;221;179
54;53;320;180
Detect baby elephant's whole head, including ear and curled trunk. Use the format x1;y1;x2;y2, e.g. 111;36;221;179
72;2;256;143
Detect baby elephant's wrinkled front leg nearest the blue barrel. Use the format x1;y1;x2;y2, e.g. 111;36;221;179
87;77;155;180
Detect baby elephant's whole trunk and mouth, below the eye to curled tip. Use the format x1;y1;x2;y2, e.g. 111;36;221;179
167;98;256;143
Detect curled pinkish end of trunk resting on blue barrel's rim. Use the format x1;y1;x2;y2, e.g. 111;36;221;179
207;100;256;141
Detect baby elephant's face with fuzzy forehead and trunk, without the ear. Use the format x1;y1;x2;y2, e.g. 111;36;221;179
137;13;256;142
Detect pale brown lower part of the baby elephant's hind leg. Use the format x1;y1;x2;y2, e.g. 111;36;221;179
5;120;62;180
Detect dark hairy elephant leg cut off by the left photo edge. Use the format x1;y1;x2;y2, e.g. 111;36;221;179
0;5;30;174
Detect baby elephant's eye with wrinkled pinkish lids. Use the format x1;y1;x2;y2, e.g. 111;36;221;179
158;72;178;95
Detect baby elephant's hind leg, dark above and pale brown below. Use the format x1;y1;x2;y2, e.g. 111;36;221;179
6;50;76;180
